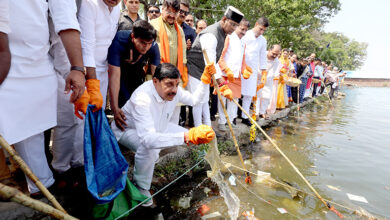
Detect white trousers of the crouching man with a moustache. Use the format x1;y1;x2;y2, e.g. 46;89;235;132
118;123;187;190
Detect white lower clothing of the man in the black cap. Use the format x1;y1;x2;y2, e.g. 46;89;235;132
187;76;211;126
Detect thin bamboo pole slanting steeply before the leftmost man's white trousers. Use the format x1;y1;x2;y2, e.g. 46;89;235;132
0;135;66;213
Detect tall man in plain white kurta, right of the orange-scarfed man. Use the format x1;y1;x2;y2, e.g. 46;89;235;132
241;17;268;126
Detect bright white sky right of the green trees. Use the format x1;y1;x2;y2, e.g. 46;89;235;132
325;0;390;78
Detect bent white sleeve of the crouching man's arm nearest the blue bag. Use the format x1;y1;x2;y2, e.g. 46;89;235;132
129;93;184;149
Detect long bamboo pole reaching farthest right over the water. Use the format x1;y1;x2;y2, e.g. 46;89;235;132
233;99;343;218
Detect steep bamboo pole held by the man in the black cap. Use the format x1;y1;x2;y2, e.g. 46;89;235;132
202;50;252;184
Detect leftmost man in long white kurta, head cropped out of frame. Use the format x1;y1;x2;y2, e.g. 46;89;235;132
0;0;85;193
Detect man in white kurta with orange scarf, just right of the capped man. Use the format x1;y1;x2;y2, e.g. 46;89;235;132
218;19;252;131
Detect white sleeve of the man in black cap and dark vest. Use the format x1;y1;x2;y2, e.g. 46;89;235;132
199;33;222;79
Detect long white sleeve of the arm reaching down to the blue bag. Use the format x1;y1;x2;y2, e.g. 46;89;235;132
78;0;97;67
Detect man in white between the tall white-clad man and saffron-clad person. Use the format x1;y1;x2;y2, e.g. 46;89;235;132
258;44;282;115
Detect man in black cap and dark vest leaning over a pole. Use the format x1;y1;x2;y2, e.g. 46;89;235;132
187;6;244;126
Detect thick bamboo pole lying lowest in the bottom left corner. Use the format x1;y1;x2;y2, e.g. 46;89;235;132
0;183;76;220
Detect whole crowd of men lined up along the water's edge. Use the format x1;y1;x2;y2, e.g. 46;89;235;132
0;0;341;206
